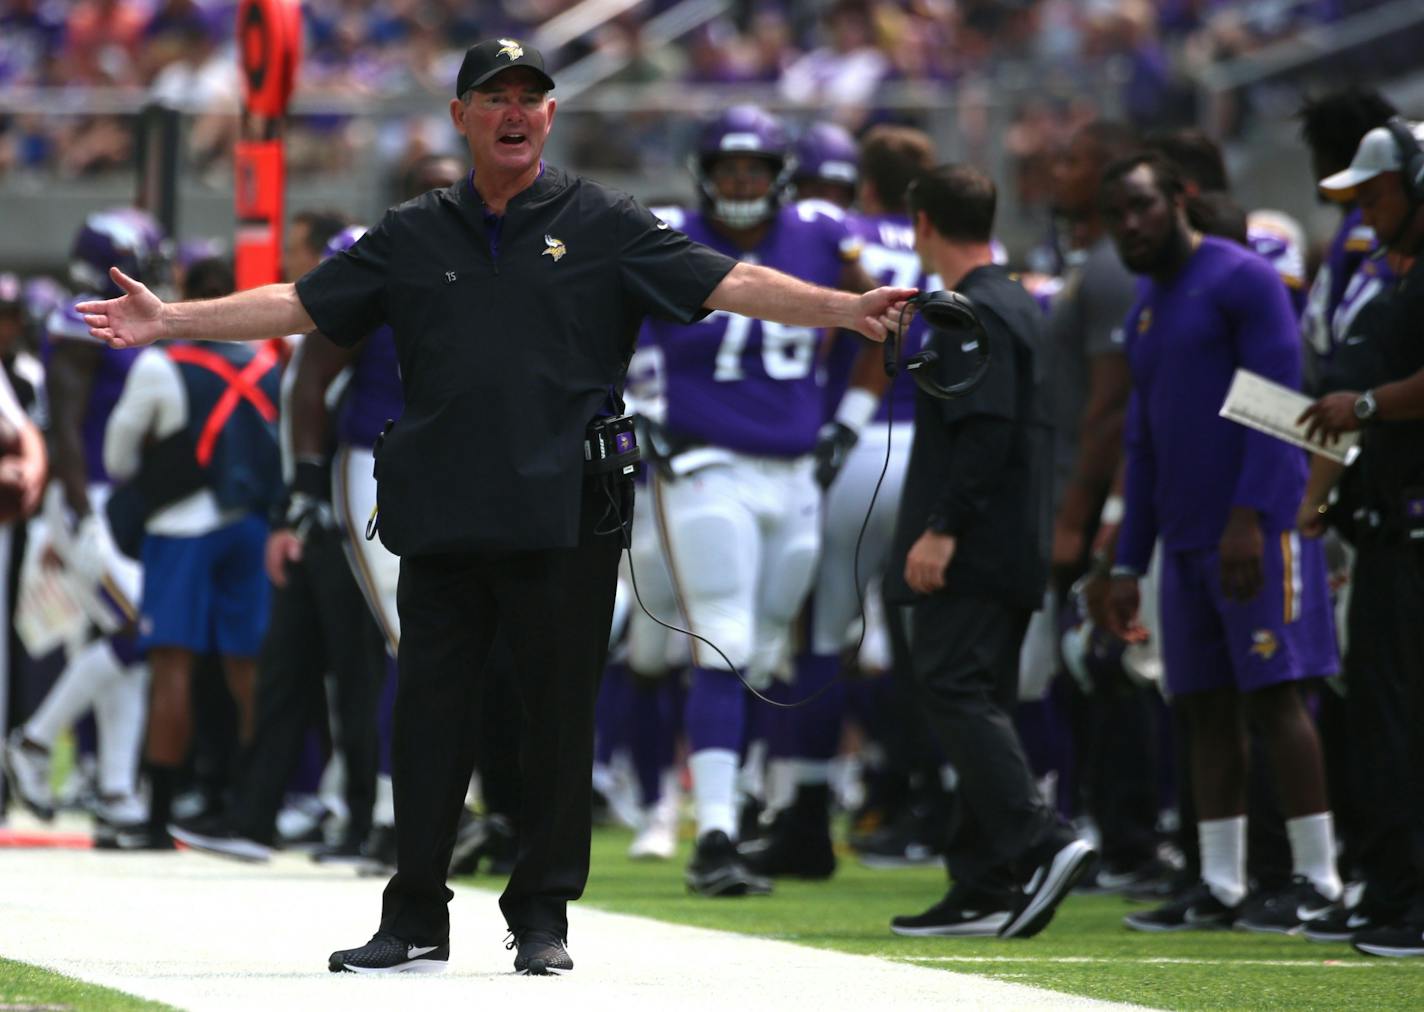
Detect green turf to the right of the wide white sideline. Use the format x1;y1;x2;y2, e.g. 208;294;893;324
471;830;1424;1009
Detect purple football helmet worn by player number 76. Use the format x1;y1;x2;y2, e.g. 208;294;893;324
692;105;796;228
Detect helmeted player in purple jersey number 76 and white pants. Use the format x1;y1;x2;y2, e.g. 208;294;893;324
644;107;870;895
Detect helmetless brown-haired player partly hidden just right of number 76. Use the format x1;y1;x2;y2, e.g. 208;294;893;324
743;125;938;878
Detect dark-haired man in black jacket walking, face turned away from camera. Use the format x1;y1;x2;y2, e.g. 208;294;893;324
886;165;1094;938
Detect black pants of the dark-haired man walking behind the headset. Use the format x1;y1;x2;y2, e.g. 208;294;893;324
910;594;1058;891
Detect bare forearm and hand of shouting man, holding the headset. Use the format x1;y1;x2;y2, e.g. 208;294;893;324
705;262;916;340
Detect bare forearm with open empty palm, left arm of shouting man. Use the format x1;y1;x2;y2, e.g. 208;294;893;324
77;268;316;347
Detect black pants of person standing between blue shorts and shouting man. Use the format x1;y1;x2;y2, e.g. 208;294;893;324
232;534;386;843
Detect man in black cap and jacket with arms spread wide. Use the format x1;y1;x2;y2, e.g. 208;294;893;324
81;38;913;974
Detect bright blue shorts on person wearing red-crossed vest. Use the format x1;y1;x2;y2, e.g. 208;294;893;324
138;514;271;658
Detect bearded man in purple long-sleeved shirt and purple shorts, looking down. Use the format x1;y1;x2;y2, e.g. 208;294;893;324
1102;155;1341;932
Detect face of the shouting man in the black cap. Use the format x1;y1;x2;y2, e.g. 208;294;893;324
450;67;555;176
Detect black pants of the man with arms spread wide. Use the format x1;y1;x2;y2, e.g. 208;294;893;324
380;487;622;945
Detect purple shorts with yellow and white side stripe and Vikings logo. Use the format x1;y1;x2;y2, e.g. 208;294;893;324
1159;531;1340;696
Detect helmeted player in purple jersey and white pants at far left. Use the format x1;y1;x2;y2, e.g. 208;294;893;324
6;208;172;848
